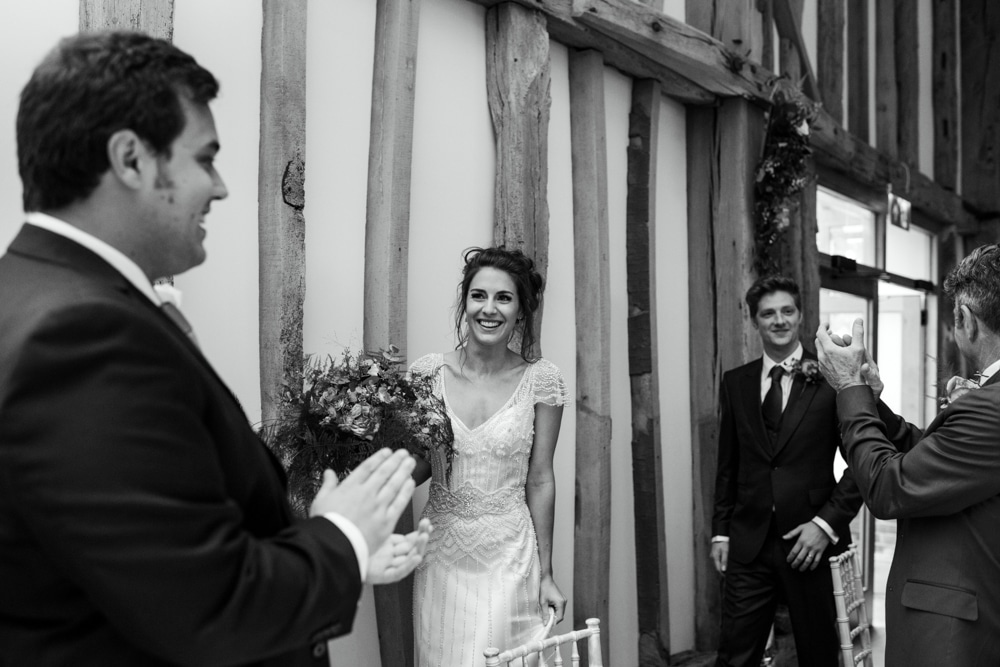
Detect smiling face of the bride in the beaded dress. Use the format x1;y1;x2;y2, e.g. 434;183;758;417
465;267;521;345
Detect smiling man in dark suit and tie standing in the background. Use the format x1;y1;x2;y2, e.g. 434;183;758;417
711;276;861;667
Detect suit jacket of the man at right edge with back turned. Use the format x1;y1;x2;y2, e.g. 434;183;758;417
837;374;1000;667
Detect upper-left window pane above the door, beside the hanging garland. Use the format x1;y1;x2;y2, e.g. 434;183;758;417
816;188;875;266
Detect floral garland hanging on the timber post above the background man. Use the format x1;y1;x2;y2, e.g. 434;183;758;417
753;79;818;276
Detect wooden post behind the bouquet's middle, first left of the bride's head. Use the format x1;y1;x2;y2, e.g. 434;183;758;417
362;0;420;667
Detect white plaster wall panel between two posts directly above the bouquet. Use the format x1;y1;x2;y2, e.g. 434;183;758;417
302;0;379;665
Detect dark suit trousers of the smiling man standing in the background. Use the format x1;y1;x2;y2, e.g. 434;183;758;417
715;515;840;667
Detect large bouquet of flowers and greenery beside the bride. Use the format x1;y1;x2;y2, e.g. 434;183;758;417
261;345;454;515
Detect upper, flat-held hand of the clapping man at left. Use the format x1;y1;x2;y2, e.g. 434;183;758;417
309;449;414;553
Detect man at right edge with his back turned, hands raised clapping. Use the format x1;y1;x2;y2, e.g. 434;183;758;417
816;245;1000;667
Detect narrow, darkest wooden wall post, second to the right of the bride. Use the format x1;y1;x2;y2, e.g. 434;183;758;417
625;79;670;667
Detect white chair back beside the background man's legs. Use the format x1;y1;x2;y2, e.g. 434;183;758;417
830;544;873;667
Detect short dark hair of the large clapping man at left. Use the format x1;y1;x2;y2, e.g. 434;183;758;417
17;32;219;211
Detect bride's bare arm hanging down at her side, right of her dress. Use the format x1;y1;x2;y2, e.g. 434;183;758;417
525;403;566;620
